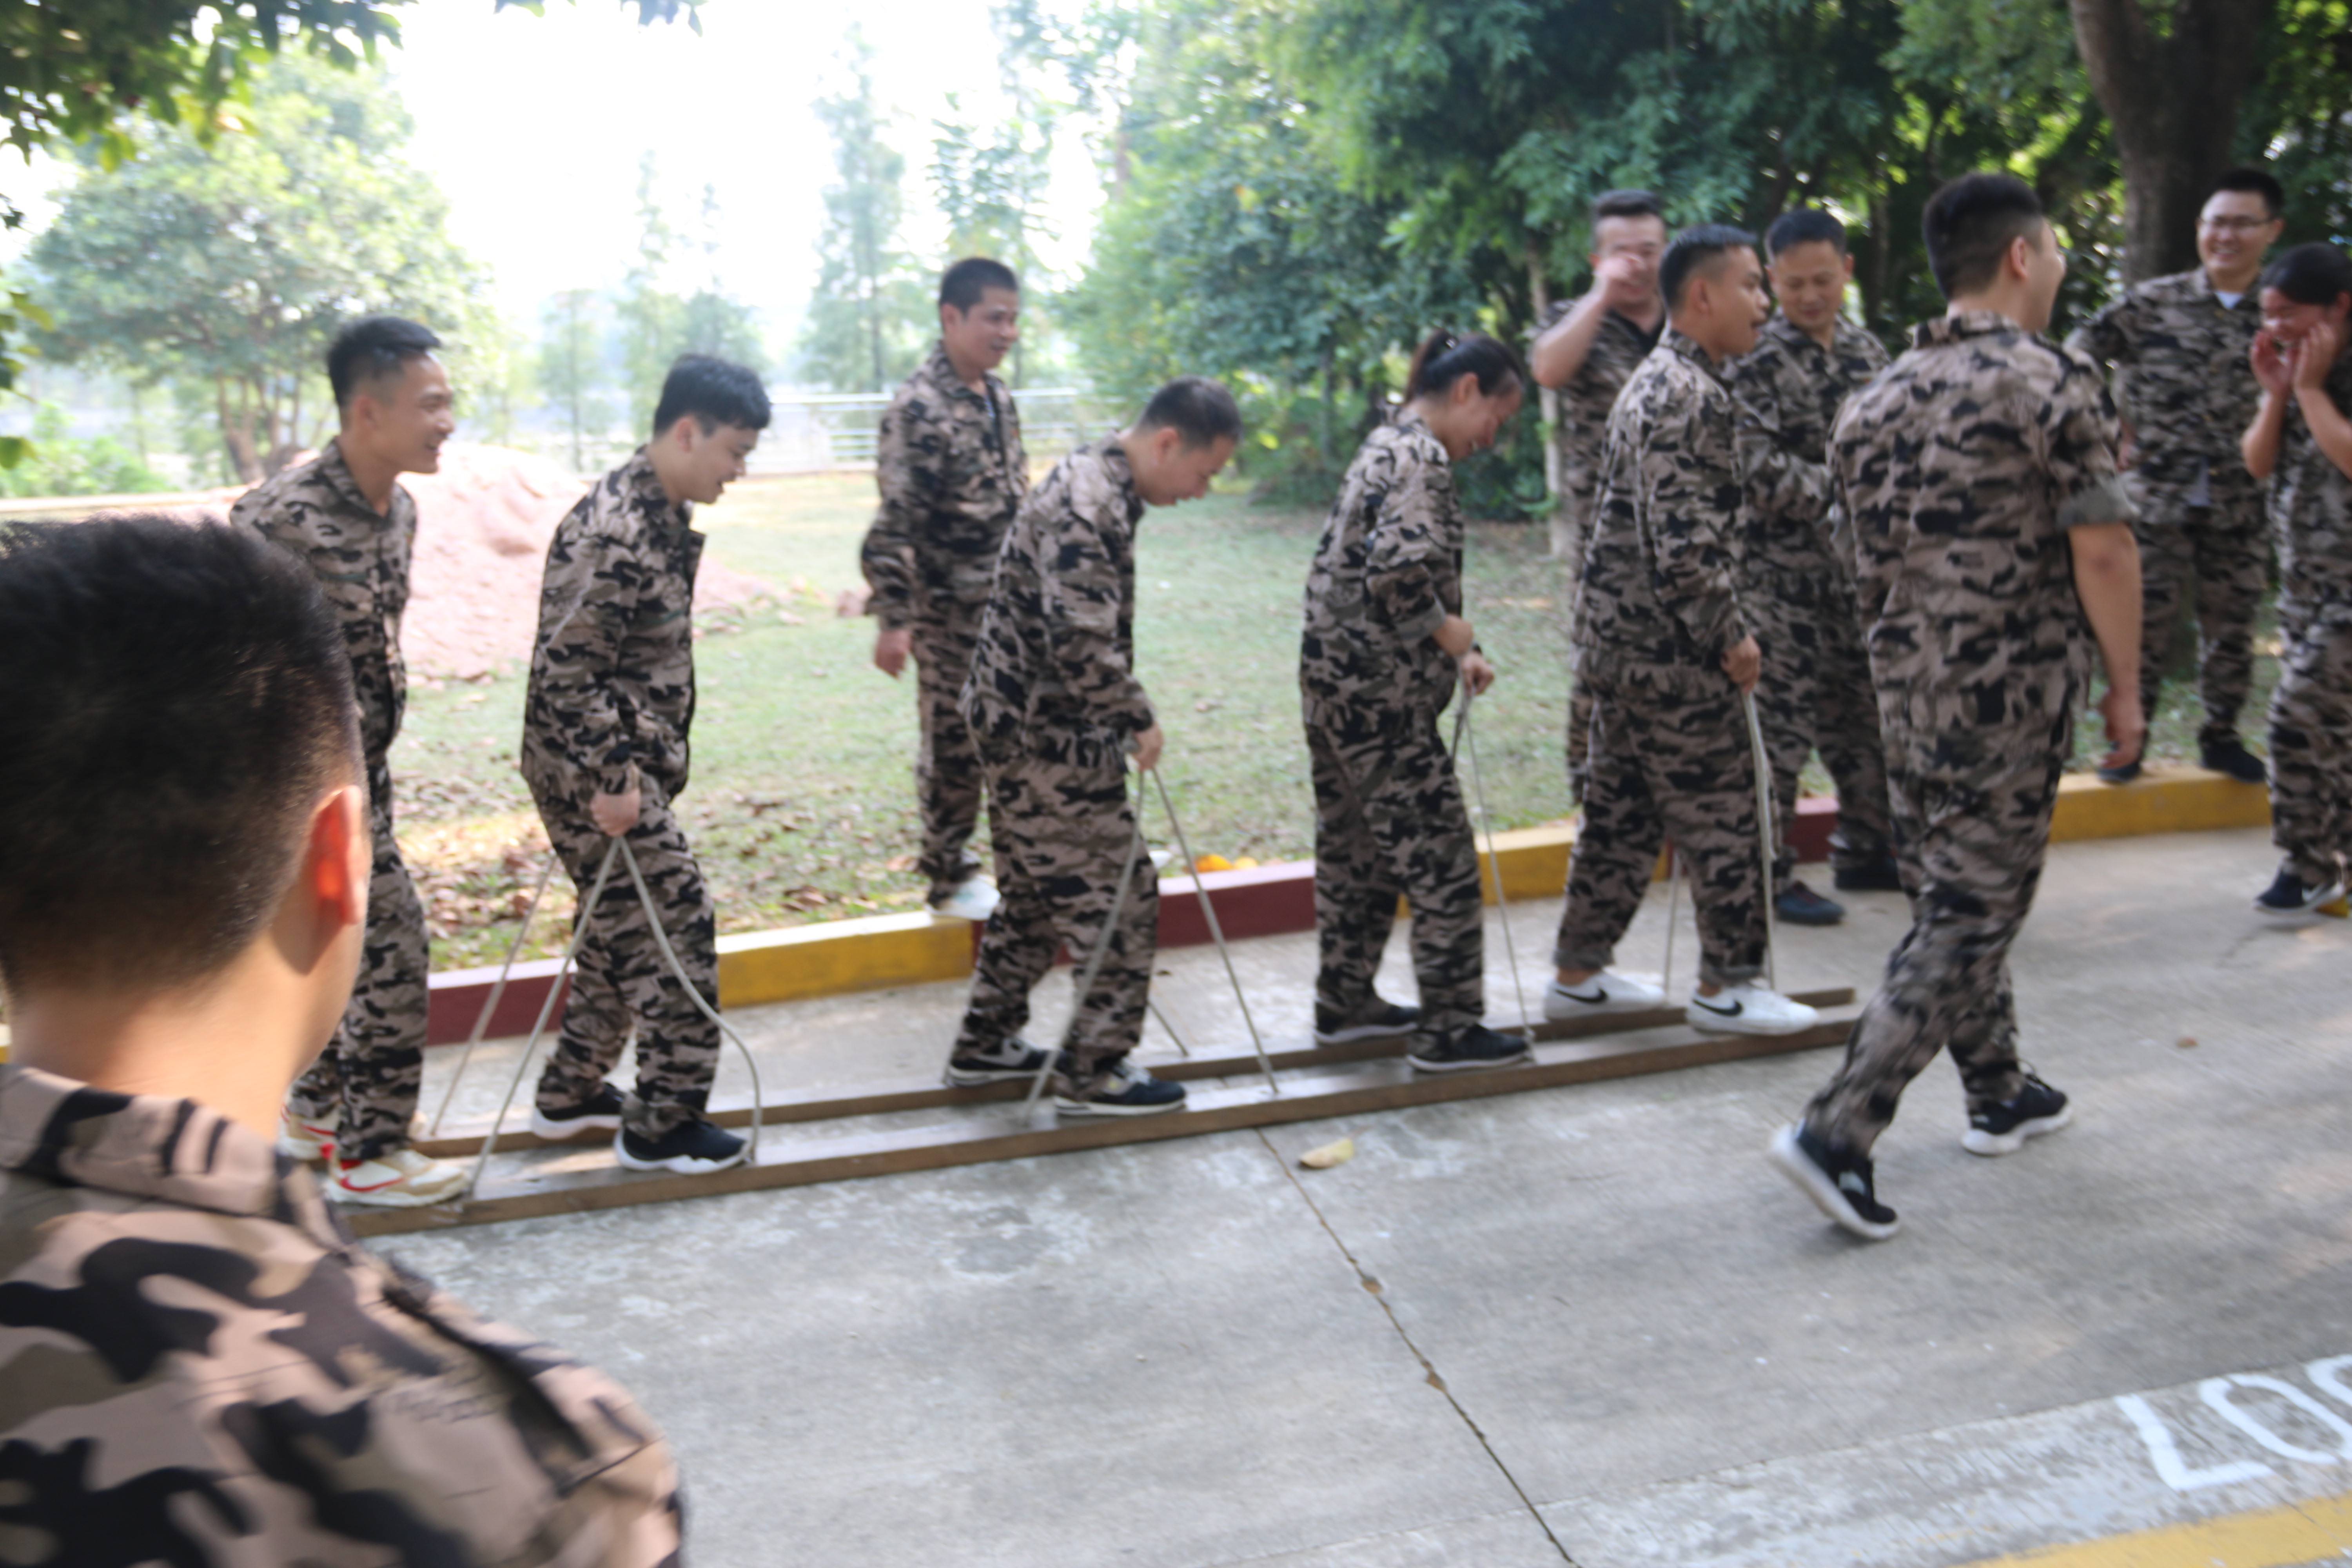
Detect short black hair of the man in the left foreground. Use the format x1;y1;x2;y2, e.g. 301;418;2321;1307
0;517;360;995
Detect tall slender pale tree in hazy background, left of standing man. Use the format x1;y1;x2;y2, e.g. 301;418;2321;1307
800;33;927;392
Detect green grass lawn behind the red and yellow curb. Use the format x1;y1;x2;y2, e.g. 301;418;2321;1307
393;475;2274;969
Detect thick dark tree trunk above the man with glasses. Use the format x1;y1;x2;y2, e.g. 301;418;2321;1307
2070;0;2277;282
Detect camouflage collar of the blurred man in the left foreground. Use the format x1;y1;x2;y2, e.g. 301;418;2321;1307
0;1065;341;1246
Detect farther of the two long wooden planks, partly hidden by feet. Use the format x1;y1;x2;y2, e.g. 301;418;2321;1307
416;985;1853;1159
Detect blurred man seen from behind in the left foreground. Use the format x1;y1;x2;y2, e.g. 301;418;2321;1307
0;517;682;1568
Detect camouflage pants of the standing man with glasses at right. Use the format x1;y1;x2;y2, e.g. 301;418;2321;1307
2131;498;2270;745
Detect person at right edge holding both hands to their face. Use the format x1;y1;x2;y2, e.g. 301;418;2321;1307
2244;242;2352;917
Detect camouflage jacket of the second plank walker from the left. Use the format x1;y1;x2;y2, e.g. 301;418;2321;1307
522;446;703;799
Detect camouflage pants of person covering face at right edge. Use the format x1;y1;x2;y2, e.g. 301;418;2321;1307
2270;625;2352;886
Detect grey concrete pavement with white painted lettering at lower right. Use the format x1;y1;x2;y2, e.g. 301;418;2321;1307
386;832;2352;1568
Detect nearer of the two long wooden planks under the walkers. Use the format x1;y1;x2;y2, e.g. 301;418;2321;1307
346;1018;1851;1236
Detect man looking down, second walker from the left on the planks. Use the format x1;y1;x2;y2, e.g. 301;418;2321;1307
520;355;769;1173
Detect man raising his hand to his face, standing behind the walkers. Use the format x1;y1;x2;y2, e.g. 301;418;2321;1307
1529;191;1665;799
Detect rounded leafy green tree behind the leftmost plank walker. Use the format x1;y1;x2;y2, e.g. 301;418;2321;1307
28;56;494;482
